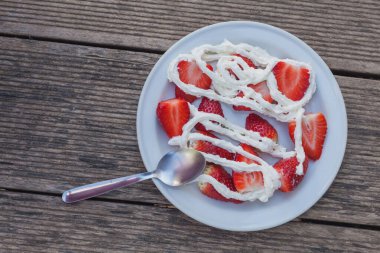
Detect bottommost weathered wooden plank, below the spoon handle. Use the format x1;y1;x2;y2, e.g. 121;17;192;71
0;191;380;252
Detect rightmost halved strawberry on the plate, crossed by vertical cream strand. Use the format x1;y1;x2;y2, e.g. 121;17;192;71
289;112;327;160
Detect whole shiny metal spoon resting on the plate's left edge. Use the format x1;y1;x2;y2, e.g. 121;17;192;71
62;149;206;203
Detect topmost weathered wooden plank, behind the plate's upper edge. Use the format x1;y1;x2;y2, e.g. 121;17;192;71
0;0;380;75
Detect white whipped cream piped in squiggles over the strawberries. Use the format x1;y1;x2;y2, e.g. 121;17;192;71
168;41;316;202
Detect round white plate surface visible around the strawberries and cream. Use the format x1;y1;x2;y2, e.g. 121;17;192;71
137;21;347;231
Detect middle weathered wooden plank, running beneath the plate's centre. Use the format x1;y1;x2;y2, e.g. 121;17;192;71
0;38;380;225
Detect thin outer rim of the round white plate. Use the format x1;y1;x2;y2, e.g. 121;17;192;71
136;21;348;232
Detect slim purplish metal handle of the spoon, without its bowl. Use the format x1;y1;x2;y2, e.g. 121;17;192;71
62;172;154;203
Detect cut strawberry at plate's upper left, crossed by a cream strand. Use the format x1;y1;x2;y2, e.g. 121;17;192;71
175;61;213;103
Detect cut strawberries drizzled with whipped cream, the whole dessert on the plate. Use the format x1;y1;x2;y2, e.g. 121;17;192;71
156;41;327;203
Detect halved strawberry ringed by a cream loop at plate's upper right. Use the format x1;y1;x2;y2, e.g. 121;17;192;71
273;61;310;101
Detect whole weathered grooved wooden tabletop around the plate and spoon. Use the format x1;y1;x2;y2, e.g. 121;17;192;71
0;0;380;252
